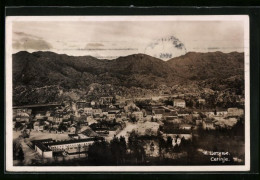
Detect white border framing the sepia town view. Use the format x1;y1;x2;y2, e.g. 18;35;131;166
5;15;250;172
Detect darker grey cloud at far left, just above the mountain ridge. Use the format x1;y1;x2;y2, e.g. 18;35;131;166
13;38;52;50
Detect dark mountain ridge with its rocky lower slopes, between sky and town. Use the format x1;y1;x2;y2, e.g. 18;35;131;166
13;51;244;105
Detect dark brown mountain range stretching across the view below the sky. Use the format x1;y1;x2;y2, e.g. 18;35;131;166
13;51;244;104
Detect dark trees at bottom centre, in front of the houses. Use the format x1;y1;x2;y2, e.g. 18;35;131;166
86;131;193;165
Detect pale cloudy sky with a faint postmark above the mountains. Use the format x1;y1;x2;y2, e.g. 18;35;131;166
12;21;244;60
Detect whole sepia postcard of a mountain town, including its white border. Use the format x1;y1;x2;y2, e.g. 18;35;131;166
5;15;250;172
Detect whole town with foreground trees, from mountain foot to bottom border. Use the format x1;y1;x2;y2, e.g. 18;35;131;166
13;94;244;165
